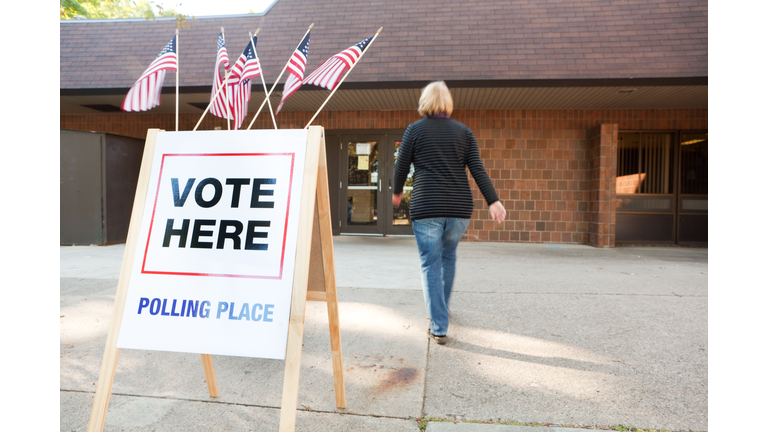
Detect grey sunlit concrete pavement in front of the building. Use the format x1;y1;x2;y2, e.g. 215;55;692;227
60;236;708;432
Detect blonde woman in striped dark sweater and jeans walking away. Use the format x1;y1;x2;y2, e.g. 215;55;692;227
392;81;507;345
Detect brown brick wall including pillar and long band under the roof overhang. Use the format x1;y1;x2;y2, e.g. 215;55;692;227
60;109;708;247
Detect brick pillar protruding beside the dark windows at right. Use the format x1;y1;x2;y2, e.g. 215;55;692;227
587;124;619;248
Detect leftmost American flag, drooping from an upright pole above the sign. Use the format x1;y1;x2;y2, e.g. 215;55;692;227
121;36;179;111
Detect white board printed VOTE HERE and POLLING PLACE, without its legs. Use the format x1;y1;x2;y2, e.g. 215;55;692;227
117;129;307;359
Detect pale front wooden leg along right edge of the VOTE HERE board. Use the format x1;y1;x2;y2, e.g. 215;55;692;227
280;126;323;432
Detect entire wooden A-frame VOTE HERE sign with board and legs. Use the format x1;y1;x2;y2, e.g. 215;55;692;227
88;126;346;432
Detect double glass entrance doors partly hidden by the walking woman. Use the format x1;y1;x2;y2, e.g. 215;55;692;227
339;134;413;235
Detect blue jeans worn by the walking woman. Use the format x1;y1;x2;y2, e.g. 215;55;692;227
413;218;469;336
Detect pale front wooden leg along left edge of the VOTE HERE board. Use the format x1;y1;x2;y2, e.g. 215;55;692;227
88;129;159;432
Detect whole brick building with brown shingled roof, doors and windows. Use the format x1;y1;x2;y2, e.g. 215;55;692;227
60;0;708;247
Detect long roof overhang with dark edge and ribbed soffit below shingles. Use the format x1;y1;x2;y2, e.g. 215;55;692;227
60;76;708;115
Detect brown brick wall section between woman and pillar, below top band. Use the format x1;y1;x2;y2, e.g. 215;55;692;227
467;128;589;243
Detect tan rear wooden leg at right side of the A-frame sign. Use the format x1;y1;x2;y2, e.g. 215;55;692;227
317;134;347;408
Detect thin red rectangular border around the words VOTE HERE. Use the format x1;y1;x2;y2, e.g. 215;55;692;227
141;153;296;280
